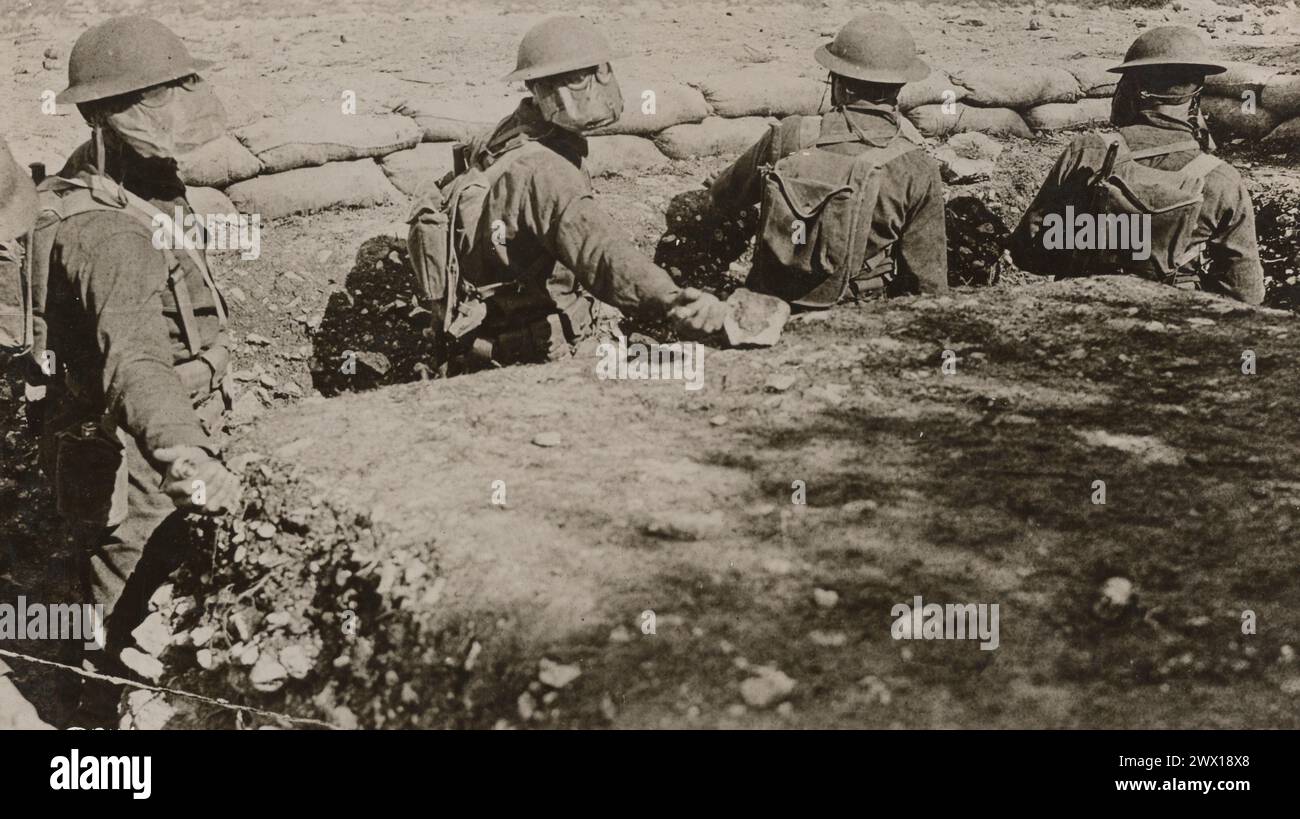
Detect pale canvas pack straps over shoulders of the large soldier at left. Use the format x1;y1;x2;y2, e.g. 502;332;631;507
0;172;228;391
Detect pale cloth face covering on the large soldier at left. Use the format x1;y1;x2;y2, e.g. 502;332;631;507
104;77;226;159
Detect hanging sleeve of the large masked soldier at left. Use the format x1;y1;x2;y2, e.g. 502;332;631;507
64;231;213;452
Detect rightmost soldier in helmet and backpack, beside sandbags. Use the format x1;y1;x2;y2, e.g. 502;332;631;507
1011;26;1264;304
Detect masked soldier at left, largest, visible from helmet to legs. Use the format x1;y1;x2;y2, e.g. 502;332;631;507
33;17;241;720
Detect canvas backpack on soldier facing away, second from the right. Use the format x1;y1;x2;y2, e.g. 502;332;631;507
750;112;920;308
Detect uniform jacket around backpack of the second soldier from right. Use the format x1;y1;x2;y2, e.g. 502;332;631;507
710;101;948;295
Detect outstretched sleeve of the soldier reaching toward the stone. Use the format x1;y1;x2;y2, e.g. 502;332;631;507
520;163;680;316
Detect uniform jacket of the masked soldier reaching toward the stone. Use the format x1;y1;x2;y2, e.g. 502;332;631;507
416;98;680;364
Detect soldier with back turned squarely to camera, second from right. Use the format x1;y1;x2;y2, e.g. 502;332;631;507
710;14;948;308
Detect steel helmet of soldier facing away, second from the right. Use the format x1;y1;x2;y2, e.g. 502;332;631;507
814;14;930;85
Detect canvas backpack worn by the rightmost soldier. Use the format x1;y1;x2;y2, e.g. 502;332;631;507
1066;134;1222;283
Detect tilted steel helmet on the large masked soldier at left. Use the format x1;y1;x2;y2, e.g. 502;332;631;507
55;16;212;105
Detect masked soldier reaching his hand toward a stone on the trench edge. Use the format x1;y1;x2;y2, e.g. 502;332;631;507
408;17;728;372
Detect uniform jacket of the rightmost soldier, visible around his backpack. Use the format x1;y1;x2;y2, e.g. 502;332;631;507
1010;116;1264;304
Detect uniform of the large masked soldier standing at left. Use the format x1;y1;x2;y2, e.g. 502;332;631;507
42;151;228;657
